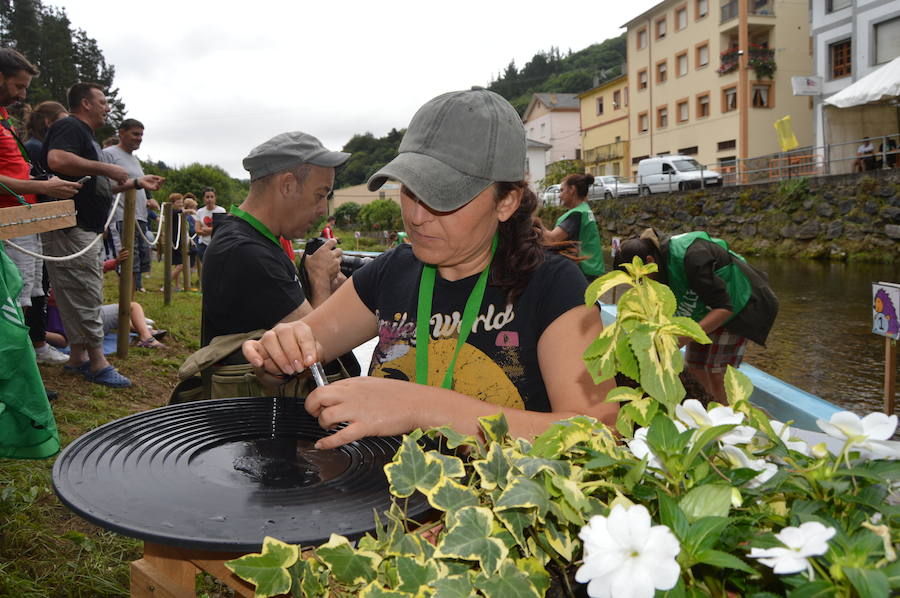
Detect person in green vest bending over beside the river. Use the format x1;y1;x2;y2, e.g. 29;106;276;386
614;228;778;403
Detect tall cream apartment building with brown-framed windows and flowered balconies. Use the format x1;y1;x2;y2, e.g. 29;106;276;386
625;0;813;180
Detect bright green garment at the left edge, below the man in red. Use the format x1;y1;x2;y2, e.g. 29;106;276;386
0;244;59;459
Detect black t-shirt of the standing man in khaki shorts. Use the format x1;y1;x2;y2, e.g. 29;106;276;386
41;116;113;233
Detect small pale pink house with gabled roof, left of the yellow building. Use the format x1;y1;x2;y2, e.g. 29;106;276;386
522;93;581;168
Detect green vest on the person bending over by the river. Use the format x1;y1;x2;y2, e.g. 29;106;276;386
667;231;753;322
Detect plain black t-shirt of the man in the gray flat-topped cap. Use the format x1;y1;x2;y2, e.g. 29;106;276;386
202;214;306;346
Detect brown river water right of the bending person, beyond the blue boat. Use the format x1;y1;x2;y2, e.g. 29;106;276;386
745;258;900;414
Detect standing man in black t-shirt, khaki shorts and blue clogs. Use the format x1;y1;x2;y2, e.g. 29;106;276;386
41;83;136;388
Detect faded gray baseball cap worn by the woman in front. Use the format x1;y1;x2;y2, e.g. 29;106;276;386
368;89;525;212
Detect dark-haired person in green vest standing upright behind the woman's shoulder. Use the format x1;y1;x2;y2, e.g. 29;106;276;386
544;174;606;282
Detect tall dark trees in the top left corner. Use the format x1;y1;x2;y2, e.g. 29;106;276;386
0;0;125;139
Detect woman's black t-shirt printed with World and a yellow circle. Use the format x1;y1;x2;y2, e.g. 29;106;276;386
351;244;587;412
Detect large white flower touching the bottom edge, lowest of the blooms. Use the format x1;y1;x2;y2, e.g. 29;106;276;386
575;505;681;598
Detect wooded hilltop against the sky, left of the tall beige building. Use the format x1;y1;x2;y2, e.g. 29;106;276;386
488;34;625;114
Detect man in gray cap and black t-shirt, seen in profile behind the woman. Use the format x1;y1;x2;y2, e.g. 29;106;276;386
202;132;350;345
